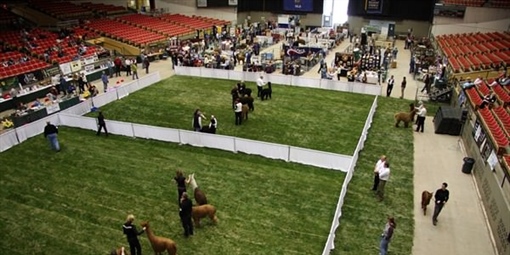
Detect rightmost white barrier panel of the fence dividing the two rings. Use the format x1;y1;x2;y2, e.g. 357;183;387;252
289;146;352;172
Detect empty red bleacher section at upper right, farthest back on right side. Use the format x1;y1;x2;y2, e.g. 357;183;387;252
436;32;510;73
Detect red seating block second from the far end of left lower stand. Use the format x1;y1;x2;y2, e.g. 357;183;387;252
117;14;195;37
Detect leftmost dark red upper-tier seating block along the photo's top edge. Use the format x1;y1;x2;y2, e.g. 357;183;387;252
29;0;92;20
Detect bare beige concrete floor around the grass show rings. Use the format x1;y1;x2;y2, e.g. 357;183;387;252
87;38;496;255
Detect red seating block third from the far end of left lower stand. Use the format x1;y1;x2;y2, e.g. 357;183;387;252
85;19;166;47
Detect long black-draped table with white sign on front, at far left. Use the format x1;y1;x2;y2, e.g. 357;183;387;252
11;96;80;127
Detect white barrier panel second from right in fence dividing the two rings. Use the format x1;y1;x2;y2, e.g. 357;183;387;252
235;138;289;161
